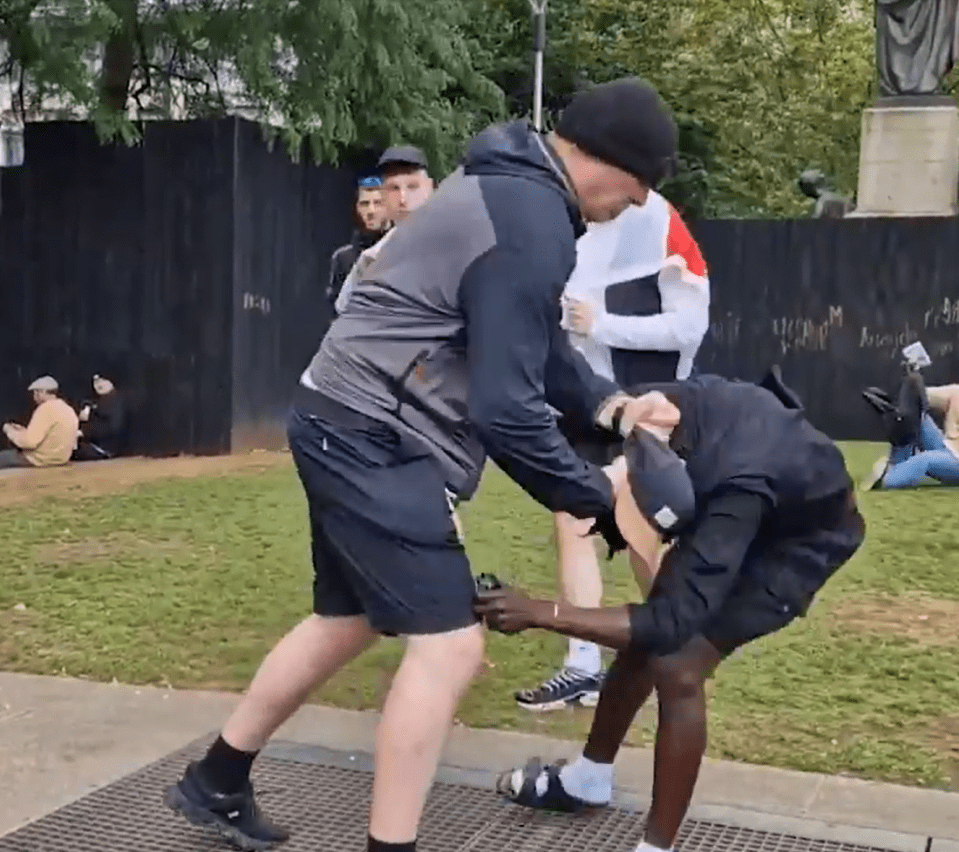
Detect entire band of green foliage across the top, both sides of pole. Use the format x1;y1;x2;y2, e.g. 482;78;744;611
0;0;900;217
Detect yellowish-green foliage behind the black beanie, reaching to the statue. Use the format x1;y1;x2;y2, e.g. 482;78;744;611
475;0;874;217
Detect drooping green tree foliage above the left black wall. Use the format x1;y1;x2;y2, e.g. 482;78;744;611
0;0;502;169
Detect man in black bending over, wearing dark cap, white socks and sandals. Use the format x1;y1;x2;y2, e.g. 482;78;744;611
476;369;865;852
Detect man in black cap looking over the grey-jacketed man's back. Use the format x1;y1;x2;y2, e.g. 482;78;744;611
334;145;433;314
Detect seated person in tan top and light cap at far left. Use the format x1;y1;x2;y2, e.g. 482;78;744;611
0;376;80;468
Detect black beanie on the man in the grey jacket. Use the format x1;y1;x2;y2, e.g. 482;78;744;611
556;77;679;188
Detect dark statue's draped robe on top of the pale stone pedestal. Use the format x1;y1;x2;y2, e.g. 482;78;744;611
876;0;959;98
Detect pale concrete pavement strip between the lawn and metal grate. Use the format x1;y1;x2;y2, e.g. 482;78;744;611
0;672;959;852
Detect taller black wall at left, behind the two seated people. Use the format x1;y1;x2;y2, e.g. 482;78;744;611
0;118;354;455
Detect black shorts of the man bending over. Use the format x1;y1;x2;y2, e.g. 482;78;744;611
650;493;866;657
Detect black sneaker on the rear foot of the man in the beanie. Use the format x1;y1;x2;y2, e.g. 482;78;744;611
163;763;290;852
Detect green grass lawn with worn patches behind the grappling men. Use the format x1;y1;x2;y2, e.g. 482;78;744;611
0;445;959;789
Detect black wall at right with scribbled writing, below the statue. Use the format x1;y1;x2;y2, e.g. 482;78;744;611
693;218;959;440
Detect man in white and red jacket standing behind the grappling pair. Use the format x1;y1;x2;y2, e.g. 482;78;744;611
516;191;709;711
